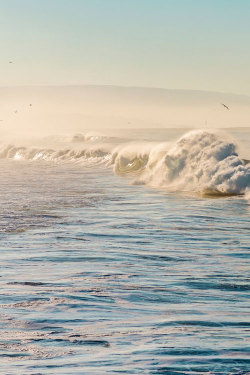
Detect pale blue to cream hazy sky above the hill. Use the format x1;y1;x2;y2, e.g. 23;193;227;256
0;0;250;95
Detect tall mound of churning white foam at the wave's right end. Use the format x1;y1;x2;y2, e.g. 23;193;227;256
114;131;250;194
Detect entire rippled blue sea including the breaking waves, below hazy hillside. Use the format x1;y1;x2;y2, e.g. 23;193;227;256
0;128;250;375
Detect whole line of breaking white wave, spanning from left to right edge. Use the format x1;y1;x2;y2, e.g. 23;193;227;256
0;130;250;196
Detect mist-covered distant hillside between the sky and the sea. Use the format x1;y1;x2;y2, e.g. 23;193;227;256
0;86;250;132
